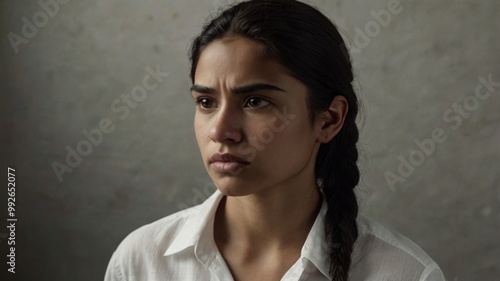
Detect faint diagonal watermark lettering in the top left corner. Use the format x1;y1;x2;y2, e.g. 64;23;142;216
7;0;70;54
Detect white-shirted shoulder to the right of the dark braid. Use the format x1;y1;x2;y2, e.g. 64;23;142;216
353;215;444;281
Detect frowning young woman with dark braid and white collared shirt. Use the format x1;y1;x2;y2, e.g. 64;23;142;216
105;0;444;281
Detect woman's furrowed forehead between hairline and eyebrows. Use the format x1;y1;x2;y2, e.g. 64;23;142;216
195;37;288;84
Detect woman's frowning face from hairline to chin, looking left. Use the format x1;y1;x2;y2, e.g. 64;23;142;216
192;37;319;196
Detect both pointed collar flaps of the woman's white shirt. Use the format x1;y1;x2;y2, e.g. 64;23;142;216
164;190;330;278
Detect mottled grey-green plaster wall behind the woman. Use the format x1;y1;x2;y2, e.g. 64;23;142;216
0;0;500;281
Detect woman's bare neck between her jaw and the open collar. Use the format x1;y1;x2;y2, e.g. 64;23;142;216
214;178;321;252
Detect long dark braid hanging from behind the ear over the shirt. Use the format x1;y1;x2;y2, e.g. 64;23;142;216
316;86;359;281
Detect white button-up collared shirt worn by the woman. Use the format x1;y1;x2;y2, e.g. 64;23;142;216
104;190;445;281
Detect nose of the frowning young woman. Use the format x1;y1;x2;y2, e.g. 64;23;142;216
209;104;242;144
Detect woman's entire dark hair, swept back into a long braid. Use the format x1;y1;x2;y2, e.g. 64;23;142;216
190;0;359;281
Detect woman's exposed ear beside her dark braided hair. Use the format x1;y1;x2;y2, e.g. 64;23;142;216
316;95;348;143
